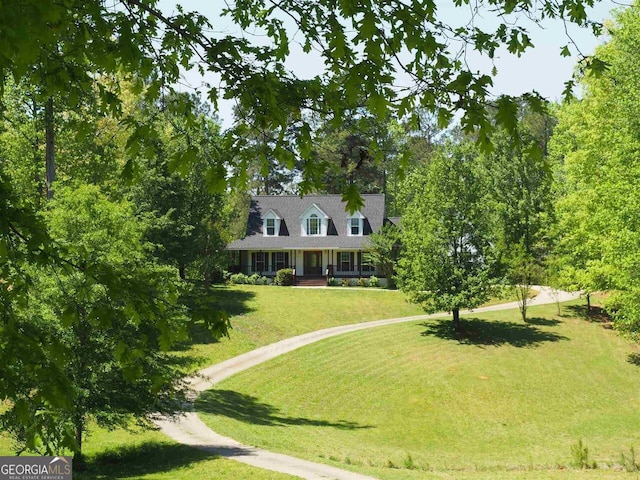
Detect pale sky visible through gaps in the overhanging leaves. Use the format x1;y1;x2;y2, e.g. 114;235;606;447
160;0;625;127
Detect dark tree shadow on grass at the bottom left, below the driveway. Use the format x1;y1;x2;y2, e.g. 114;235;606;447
73;442;212;480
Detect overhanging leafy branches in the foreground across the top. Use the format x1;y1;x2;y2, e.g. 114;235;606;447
0;0;599;207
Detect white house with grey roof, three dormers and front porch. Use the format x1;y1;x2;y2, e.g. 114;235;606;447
227;195;388;284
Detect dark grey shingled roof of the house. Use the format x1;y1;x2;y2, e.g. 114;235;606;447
227;194;385;250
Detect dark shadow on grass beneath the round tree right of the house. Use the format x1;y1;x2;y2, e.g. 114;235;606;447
421;318;568;348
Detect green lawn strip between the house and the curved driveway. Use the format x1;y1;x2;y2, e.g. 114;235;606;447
178;285;424;369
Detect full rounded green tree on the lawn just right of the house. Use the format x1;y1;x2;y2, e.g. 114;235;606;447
397;144;494;330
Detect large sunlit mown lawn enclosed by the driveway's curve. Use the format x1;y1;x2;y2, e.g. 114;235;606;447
198;302;640;479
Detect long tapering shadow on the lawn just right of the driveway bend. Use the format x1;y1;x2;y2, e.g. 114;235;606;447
196;390;373;430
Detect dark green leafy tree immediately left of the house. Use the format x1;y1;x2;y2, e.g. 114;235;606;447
120;93;224;284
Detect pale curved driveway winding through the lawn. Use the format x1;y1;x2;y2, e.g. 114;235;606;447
156;286;579;480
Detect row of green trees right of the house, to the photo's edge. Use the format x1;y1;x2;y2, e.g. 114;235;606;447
374;5;640;341
